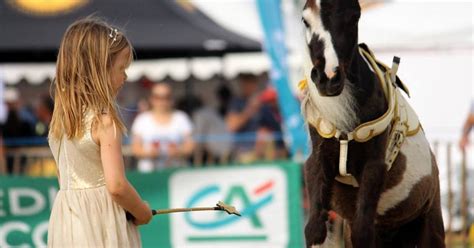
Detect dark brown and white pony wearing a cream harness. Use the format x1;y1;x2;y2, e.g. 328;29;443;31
302;0;445;248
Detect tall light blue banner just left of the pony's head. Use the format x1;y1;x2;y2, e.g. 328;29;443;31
256;0;309;156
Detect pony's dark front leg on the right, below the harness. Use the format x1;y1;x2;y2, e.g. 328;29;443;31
351;160;387;248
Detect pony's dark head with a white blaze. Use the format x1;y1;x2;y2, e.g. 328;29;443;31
303;0;360;96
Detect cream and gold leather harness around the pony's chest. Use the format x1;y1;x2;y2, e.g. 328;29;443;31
299;44;421;187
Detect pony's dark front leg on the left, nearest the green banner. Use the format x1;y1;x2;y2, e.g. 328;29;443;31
305;154;335;247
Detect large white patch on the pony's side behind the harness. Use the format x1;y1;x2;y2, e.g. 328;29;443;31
377;130;432;215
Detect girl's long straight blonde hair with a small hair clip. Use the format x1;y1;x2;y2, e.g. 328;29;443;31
50;17;133;139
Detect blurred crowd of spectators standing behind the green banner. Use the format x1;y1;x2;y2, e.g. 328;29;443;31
0;74;287;173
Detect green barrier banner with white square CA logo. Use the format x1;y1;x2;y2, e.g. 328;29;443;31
0;162;303;248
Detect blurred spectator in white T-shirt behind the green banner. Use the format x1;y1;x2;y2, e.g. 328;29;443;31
132;83;194;172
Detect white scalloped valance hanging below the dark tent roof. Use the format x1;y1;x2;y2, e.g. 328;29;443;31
0;53;270;85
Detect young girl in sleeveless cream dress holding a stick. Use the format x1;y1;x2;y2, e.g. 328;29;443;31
48;17;152;247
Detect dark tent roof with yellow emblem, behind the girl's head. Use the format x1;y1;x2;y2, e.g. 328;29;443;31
0;0;261;62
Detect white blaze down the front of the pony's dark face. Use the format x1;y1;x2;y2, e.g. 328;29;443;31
303;8;339;79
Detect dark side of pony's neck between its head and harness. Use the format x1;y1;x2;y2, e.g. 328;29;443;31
348;47;388;123
